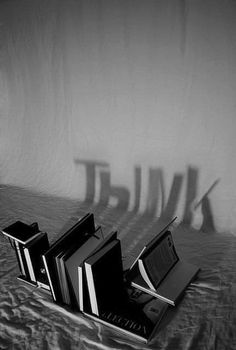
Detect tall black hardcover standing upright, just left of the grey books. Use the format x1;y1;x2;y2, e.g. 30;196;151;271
43;214;95;303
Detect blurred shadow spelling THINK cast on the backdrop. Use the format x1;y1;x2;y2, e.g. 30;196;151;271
75;159;219;239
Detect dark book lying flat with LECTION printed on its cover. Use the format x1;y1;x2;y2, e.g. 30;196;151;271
85;286;168;343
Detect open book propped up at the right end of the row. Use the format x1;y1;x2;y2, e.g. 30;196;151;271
126;218;199;305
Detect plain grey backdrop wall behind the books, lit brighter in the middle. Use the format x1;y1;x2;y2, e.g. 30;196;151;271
0;0;236;230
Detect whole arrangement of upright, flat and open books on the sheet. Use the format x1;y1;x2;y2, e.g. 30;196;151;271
2;213;198;342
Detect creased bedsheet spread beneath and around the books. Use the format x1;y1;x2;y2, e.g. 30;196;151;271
0;186;236;350
